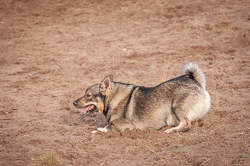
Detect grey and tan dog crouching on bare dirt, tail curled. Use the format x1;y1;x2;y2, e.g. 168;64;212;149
73;62;211;133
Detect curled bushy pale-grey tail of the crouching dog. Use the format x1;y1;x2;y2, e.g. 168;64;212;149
181;62;206;90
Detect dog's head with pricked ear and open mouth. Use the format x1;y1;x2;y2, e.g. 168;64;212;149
73;75;113;115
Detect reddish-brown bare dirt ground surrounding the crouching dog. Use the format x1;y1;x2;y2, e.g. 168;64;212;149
0;0;250;166
